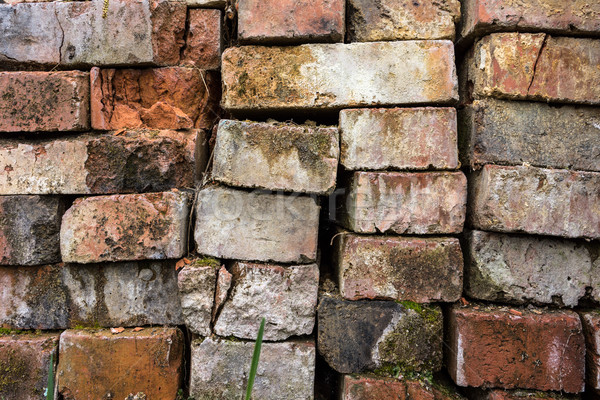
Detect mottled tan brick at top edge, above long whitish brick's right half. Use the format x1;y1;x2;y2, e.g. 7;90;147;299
348;0;460;42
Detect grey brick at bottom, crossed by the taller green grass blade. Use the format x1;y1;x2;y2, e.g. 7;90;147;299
190;338;315;400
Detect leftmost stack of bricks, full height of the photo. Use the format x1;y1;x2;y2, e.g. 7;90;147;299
0;0;222;400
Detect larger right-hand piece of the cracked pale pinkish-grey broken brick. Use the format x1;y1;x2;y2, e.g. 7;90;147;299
215;262;319;340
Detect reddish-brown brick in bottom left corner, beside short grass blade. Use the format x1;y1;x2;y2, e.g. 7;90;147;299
0;332;59;400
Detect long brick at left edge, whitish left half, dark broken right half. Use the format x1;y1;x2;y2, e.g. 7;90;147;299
0;130;207;195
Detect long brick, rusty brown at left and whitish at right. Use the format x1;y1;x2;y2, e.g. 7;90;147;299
222;41;458;111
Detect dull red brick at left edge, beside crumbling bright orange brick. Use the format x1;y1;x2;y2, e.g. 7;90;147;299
0;71;90;132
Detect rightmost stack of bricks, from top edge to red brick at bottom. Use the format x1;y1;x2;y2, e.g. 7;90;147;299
447;0;600;398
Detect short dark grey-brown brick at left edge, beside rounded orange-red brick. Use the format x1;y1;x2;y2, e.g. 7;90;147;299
0;196;64;265
